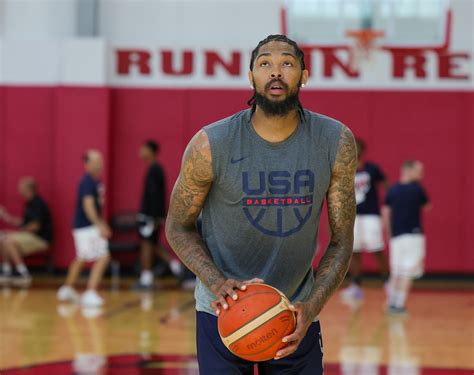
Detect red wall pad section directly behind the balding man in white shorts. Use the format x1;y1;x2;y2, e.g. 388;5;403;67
50;87;112;268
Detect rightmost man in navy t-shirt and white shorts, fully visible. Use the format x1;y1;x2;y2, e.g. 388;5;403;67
383;160;430;314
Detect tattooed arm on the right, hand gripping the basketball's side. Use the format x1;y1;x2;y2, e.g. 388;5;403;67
275;127;357;359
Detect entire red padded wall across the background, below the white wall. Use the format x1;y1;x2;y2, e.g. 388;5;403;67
0;87;474;273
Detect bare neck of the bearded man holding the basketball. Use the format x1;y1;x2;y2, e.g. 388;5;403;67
252;106;298;143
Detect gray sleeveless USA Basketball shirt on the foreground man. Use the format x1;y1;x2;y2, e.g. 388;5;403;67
195;110;342;315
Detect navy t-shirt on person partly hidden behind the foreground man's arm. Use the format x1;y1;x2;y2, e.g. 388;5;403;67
355;162;385;215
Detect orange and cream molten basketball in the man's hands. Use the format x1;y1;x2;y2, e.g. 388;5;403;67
217;284;296;362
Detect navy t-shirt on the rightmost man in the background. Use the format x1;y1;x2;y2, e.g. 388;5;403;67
385;182;429;237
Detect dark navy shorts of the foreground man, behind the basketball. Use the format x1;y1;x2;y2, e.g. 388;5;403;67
196;311;323;375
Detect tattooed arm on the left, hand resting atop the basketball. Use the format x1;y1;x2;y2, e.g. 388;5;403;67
166;130;250;313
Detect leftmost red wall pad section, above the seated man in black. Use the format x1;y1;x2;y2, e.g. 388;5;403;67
0;87;54;225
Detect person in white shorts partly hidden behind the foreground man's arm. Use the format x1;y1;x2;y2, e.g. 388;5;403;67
342;138;388;302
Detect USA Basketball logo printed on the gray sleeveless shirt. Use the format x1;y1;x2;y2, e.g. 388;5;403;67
242;169;314;237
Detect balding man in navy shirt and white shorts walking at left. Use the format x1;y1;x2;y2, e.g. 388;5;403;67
57;150;112;307
